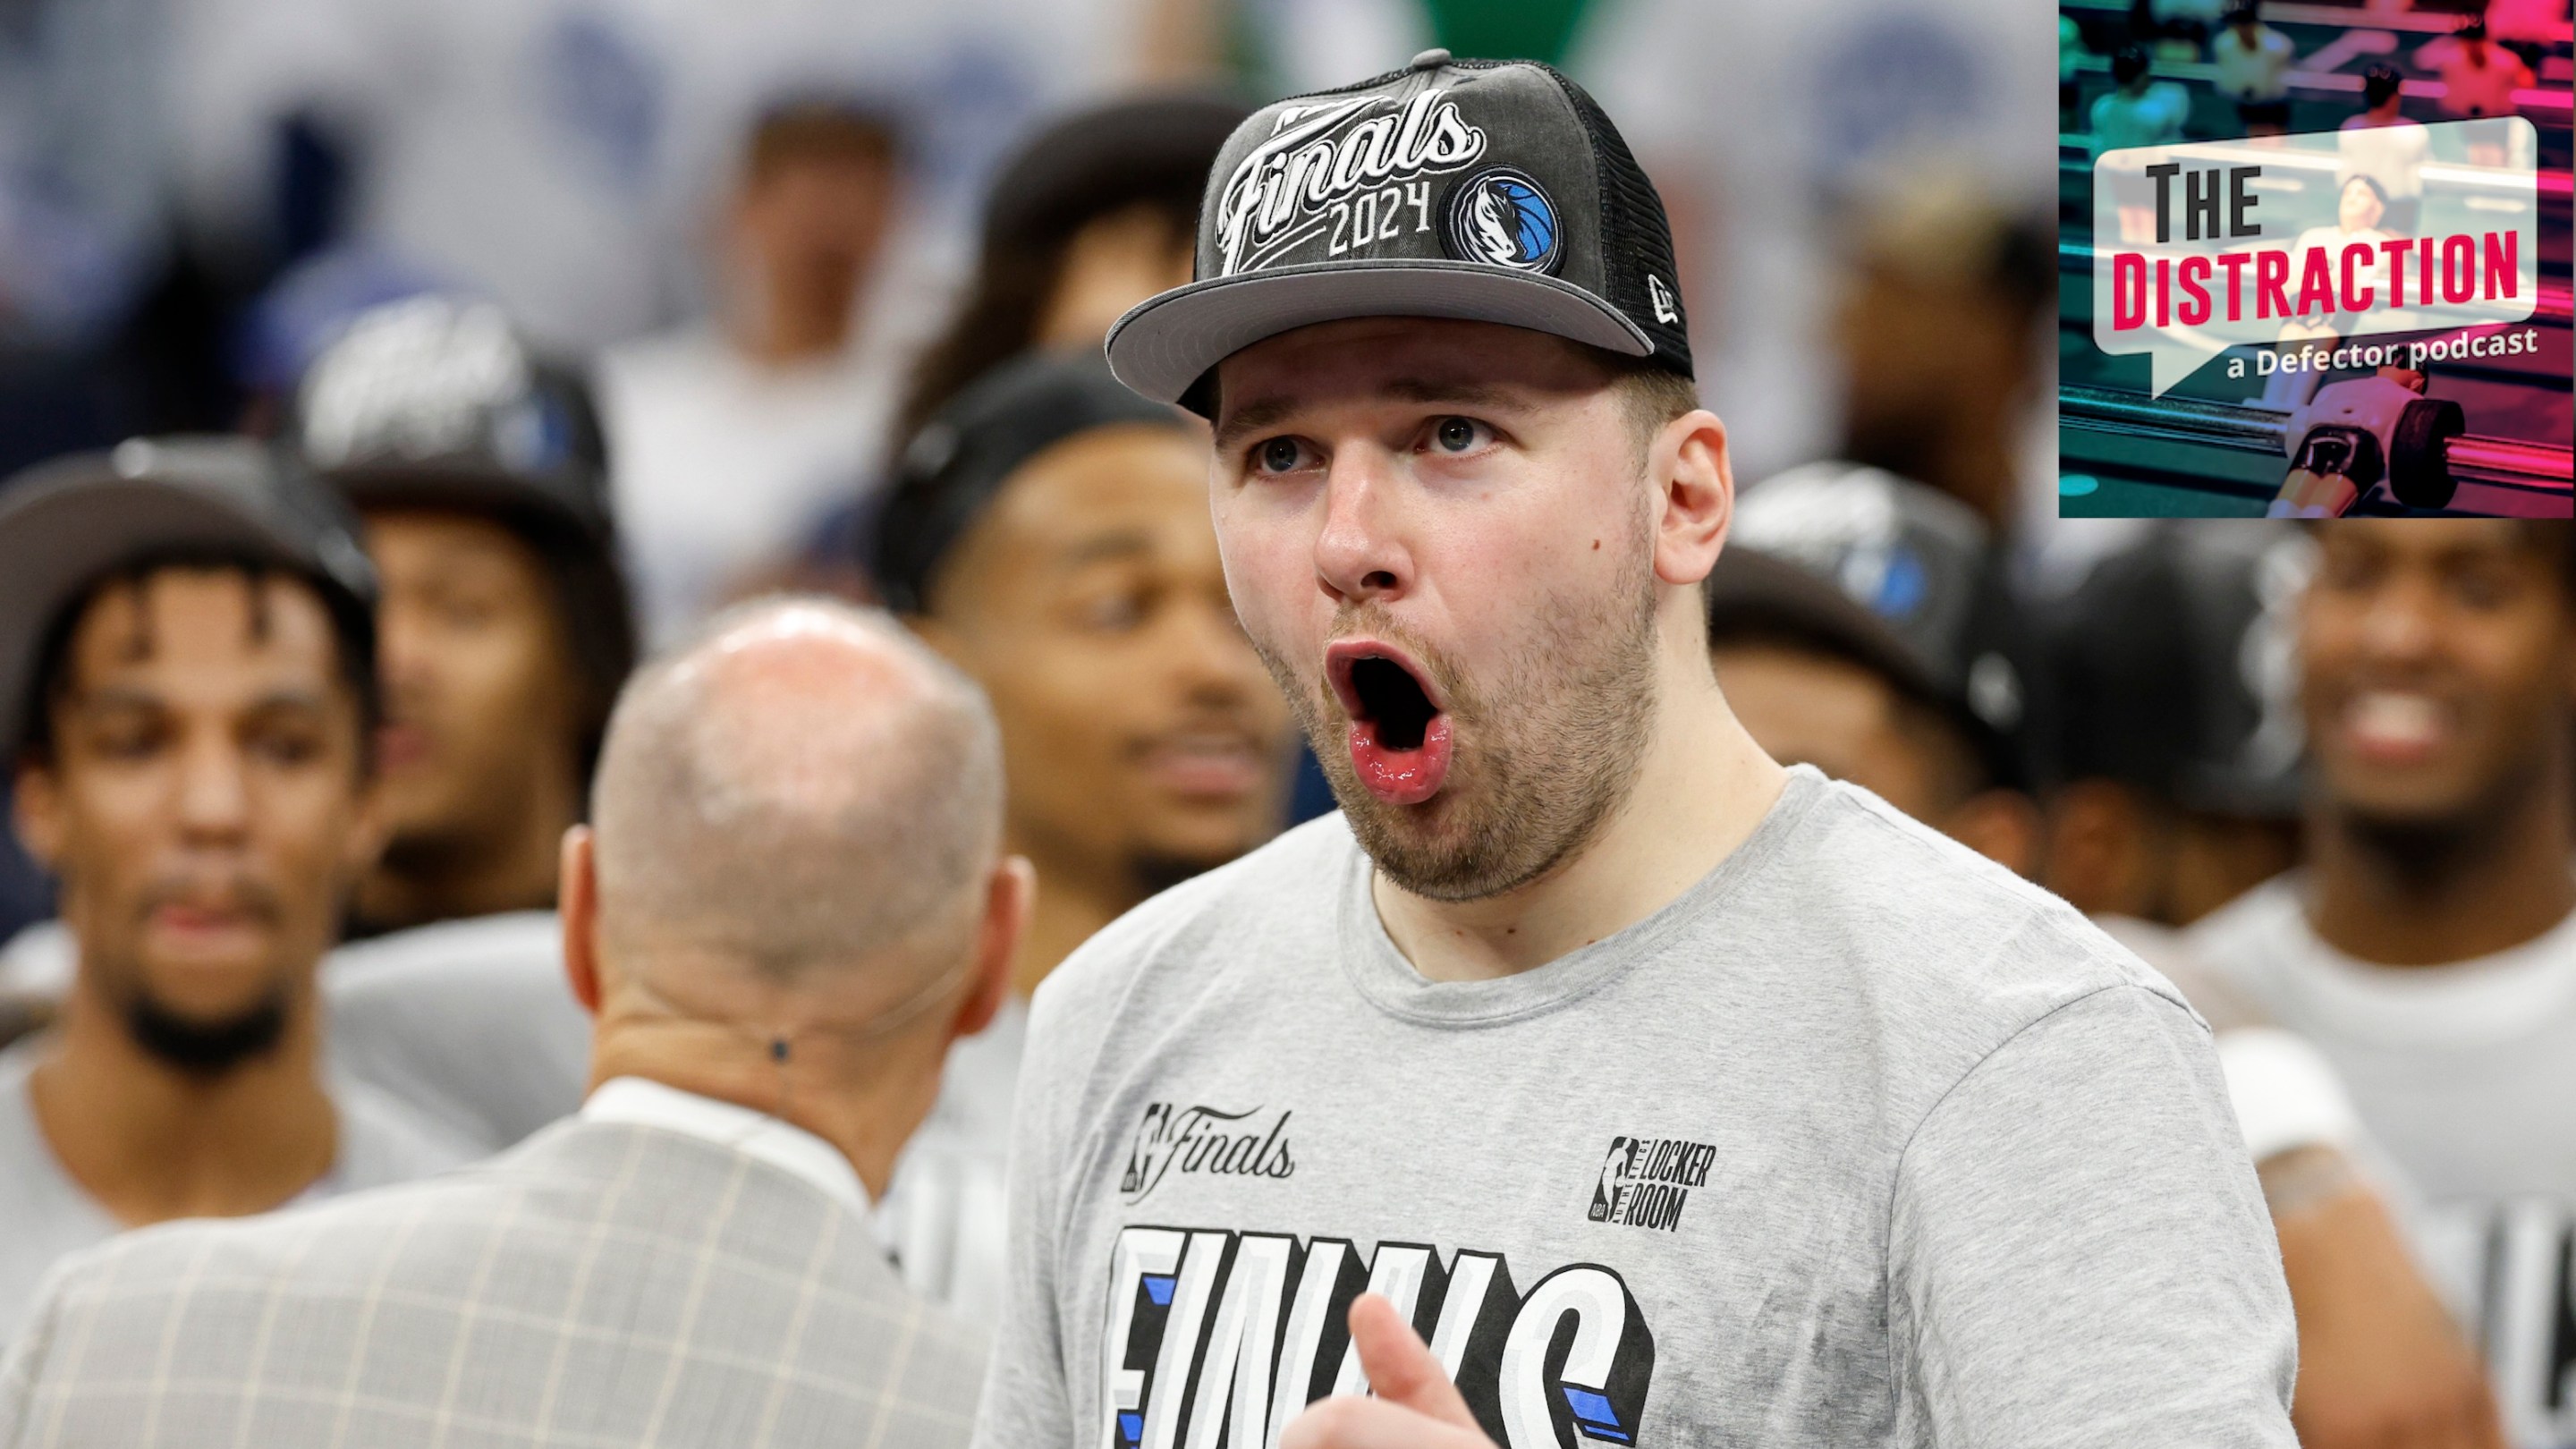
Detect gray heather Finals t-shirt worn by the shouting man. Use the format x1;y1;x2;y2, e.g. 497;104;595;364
977;768;2295;1449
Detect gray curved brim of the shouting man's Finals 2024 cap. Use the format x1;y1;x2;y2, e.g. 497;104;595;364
1107;260;1654;402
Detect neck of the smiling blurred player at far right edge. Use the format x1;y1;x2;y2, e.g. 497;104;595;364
2308;768;2576;967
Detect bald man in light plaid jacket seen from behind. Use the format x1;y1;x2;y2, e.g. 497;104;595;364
0;601;1030;1449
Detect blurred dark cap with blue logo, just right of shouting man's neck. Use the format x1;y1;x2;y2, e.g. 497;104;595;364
1706;462;2028;786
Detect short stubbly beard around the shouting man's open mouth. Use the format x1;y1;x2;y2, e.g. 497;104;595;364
1262;513;1657;900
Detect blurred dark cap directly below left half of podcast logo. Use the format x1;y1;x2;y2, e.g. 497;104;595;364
2043;521;2313;820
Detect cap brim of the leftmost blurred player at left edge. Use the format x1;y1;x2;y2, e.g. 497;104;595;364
0;477;309;756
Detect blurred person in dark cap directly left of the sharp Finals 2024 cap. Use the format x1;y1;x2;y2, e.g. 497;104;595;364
896;96;1247;441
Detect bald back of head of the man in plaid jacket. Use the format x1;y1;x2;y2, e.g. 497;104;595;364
590;598;1002;985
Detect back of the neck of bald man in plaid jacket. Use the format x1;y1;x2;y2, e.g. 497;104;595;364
590;1021;943;1201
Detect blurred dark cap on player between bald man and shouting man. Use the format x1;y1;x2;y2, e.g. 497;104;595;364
869;353;1185;614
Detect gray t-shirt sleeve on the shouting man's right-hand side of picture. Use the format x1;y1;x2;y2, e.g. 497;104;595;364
1888;985;2298;1449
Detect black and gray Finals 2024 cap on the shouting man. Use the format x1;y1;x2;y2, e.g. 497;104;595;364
1107;49;1690;412
